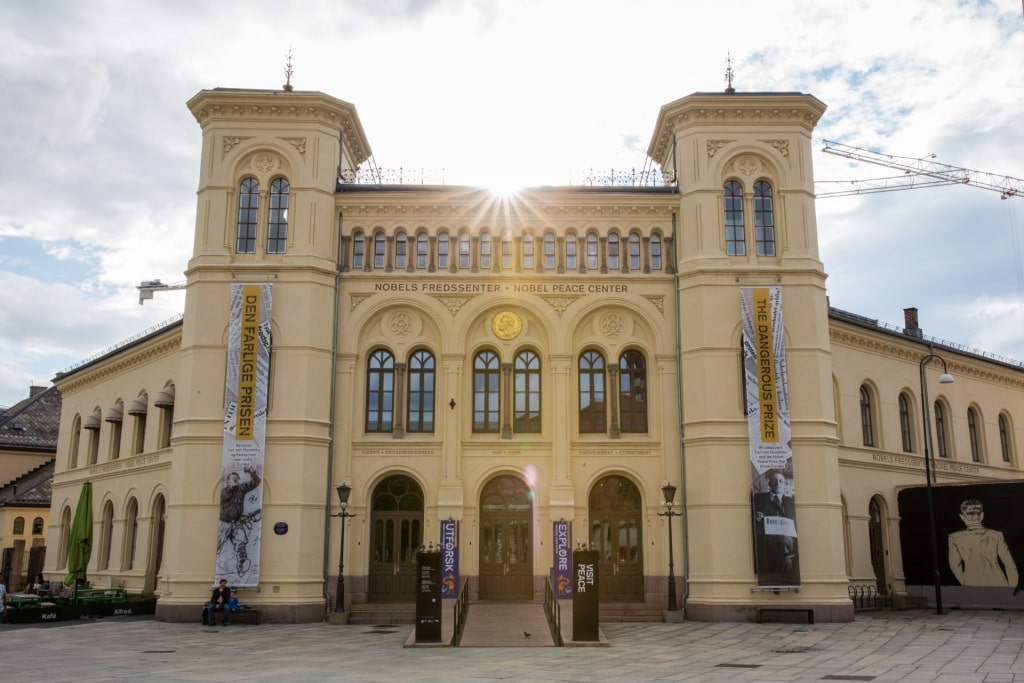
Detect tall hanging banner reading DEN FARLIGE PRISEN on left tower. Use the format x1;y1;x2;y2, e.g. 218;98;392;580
214;285;271;587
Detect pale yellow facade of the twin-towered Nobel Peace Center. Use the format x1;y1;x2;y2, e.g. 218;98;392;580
47;90;1024;622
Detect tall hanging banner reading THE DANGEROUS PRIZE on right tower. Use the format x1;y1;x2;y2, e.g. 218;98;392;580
739;287;800;586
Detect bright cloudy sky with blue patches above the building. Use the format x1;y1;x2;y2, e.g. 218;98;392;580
0;0;1024;405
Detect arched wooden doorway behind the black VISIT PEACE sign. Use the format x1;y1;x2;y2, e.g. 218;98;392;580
590;476;643;602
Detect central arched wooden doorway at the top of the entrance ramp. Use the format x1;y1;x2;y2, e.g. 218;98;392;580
480;475;534;600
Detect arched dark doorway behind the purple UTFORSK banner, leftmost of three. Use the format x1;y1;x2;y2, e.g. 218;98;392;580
369;474;423;601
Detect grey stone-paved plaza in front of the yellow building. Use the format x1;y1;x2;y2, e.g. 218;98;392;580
6;610;1024;683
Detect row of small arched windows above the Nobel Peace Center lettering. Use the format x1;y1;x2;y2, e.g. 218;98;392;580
343;229;667;272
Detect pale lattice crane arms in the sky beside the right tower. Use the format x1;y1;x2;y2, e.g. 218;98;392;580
817;140;1024;200
